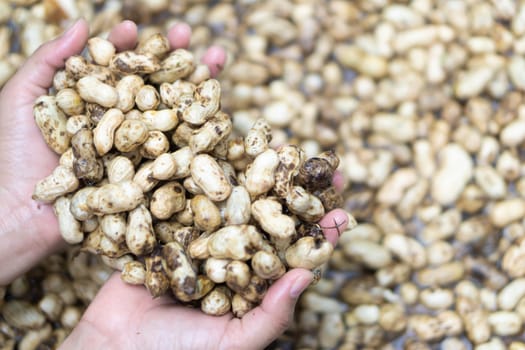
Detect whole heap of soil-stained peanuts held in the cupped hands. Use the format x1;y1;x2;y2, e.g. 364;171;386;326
33;34;351;317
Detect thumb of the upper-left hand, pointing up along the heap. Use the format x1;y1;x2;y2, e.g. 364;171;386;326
4;19;89;107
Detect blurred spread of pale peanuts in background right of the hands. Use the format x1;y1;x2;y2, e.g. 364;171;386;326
5;0;525;350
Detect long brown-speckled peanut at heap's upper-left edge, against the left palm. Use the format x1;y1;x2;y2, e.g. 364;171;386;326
33;96;70;154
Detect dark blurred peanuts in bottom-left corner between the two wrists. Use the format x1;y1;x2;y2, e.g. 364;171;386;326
0;247;113;350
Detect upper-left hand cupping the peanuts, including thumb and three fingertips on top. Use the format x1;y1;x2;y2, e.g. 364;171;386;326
0;20;226;285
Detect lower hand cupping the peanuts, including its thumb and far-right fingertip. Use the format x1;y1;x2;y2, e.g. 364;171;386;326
62;209;348;350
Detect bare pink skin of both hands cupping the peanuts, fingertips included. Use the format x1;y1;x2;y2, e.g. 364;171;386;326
0;20;347;349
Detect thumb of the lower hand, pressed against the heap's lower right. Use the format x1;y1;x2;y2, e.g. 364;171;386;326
236;268;313;349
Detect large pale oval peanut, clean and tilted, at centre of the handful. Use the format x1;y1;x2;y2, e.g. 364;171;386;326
190;154;232;202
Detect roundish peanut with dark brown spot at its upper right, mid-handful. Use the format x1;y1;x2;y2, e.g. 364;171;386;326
149;181;186;220
